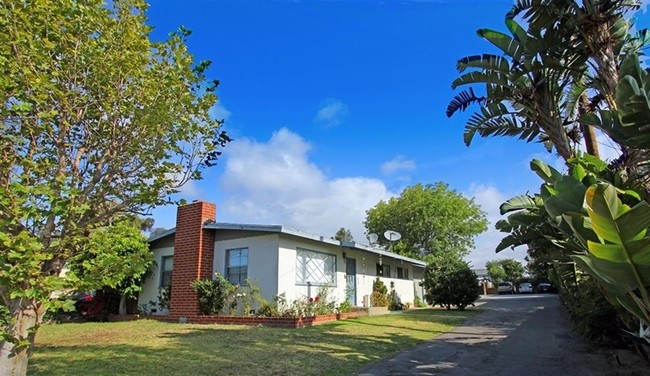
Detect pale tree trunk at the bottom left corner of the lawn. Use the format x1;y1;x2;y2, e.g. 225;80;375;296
0;304;45;376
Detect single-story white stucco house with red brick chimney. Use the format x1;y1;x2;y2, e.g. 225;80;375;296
138;201;426;316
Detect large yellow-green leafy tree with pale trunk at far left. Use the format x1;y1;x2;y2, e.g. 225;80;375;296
0;0;229;375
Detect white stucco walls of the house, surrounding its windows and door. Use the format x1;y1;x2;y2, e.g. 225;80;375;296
138;231;422;314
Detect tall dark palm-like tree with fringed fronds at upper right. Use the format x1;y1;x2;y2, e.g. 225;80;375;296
447;0;647;161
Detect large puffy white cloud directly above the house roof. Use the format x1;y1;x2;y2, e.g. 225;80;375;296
217;128;393;243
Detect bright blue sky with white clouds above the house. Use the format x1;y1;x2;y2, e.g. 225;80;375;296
147;0;650;268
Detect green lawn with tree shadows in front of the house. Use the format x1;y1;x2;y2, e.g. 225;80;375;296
28;309;478;376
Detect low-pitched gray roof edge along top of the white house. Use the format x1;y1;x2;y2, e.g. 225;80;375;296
149;222;427;267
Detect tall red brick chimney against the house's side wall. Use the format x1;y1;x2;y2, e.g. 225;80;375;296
169;201;217;317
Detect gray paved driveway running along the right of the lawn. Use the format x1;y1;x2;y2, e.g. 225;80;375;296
359;295;635;376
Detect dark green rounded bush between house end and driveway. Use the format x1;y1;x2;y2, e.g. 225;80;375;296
424;259;479;311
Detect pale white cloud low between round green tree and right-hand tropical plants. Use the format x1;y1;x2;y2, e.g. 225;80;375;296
465;184;526;269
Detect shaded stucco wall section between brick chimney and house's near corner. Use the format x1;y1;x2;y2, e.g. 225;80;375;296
213;234;279;300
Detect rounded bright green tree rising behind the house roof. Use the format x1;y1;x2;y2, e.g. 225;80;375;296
364;183;487;259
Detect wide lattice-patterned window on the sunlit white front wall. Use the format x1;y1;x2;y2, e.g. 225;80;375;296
296;249;336;286
